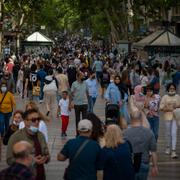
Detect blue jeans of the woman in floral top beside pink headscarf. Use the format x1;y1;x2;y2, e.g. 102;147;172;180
147;116;159;141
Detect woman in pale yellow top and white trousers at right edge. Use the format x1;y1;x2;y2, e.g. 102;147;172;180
160;83;180;158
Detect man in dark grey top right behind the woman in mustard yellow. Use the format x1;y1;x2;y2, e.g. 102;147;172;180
0;71;15;94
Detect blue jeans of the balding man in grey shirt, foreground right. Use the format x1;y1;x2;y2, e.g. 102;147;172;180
135;163;150;180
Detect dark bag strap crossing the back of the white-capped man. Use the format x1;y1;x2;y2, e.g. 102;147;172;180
63;139;90;180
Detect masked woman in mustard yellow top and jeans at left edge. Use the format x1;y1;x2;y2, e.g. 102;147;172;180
0;82;16;137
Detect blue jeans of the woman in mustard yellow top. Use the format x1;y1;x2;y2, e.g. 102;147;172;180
0;112;12;136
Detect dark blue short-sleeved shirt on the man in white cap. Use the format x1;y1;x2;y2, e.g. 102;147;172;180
61;136;101;180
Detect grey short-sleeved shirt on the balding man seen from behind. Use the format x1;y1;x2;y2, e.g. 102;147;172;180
124;126;156;163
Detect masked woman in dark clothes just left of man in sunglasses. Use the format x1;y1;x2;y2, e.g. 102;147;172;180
3;110;23;145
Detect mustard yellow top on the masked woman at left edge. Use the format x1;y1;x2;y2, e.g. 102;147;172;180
0;91;16;113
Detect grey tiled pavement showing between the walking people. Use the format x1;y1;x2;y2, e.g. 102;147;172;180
0;93;180;180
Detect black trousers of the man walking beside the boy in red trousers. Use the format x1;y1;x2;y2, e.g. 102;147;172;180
74;104;87;129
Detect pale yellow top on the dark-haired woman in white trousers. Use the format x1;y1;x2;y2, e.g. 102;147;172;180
160;94;180;121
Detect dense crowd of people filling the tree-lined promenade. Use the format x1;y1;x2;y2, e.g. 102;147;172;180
0;39;180;180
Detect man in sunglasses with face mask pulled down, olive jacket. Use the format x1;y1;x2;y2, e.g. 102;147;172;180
6;109;50;180
